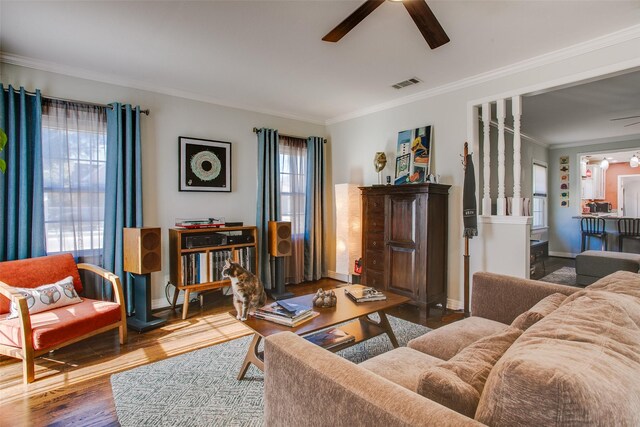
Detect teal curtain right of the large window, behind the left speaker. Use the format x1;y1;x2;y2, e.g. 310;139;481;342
103;102;142;315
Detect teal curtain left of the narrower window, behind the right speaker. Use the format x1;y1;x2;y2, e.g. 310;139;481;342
256;128;280;289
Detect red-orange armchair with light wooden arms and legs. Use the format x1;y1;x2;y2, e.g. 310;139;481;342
0;254;127;383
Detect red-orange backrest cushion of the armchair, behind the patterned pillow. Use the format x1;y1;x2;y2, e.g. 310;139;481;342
0;254;82;314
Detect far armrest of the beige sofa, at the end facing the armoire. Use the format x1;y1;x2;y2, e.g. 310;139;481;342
471;273;581;325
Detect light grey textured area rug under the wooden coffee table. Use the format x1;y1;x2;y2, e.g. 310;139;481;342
111;316;430;427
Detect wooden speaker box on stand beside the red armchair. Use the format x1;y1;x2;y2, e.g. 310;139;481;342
123;227;162;274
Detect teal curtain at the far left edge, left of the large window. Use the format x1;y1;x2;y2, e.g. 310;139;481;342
0;83;46;261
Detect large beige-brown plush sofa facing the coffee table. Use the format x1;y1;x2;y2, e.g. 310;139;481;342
265;272;640;426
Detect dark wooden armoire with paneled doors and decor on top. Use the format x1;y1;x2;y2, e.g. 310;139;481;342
360;183;451;315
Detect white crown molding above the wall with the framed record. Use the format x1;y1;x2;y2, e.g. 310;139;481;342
0;51;325;126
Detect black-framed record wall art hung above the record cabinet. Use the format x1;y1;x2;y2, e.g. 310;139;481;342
178;136;231;192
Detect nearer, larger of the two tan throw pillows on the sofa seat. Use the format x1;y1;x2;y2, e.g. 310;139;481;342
418;327;522;418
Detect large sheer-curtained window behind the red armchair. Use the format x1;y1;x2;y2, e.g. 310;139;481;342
42;99;107;261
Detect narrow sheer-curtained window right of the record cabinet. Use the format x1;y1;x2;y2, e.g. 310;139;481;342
278;135;307;283
